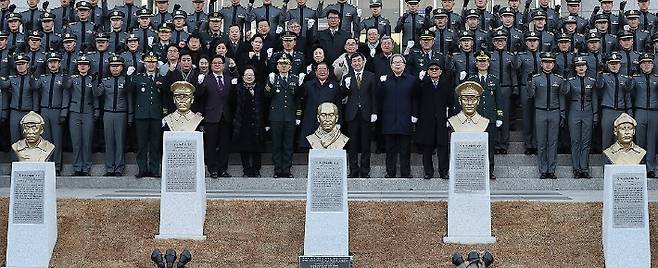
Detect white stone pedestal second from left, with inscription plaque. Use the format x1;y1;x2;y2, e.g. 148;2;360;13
155;131;206;240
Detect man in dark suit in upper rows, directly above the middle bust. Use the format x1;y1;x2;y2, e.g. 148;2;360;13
311;9;351;64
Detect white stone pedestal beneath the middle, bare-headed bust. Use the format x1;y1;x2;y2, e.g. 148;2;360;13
304;149;349;256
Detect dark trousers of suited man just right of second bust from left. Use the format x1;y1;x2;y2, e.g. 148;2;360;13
204;118;231;173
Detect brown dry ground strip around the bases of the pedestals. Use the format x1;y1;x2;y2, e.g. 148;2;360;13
0;198;658;268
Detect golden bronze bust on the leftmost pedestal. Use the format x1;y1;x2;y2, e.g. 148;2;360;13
11;111;55;162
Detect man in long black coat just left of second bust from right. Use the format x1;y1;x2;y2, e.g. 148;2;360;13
416;58;454;179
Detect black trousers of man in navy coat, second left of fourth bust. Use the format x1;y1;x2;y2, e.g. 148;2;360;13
384;134;411;177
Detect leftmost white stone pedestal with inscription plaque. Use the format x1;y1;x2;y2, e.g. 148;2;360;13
6;162;57;268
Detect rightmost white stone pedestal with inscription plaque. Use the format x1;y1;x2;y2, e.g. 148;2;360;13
602;165;651;268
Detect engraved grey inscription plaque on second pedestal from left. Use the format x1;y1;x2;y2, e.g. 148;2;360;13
165;139;198;193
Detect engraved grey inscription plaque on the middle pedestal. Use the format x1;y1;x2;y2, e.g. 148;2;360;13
308;157;345;212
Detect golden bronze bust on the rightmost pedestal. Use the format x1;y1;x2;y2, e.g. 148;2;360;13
603;113;647;165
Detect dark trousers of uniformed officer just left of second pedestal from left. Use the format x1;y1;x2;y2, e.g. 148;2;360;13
135;119;162;174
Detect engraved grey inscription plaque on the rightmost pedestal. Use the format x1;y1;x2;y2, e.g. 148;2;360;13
612;174;646;228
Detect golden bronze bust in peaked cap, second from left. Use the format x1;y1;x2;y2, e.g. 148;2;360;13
163;81;203;131
